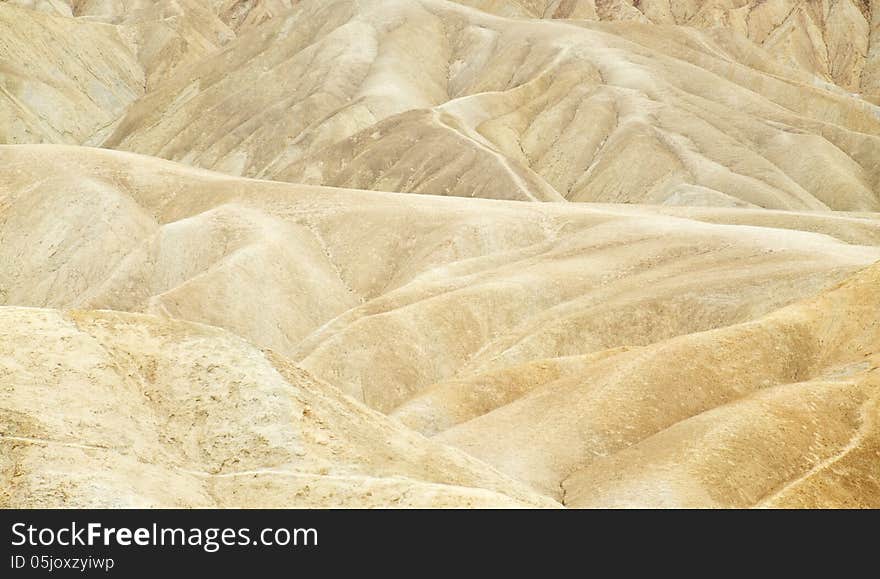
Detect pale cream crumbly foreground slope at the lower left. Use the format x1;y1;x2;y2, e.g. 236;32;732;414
0;307;554;508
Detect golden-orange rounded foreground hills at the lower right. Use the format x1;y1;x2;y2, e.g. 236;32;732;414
438;266;880;507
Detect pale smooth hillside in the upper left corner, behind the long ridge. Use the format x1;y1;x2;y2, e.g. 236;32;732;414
0;4;144;144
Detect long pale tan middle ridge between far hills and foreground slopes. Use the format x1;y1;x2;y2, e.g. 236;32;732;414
0;146;880;411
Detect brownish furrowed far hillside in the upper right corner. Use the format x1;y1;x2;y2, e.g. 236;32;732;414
459;0;880;94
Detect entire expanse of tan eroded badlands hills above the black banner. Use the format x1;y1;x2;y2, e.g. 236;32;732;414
0;0;880;508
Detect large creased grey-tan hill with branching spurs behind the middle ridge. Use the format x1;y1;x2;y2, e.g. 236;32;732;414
99;0;880;210
